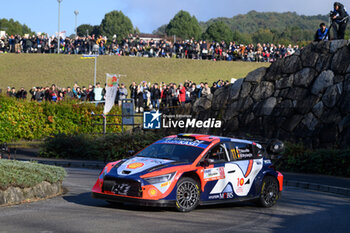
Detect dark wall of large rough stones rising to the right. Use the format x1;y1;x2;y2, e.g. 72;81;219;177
192;40;350;148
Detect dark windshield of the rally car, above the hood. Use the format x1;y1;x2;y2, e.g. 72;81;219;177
136;143;204;163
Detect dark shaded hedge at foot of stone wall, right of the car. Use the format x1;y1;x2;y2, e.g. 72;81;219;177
276;144;350;177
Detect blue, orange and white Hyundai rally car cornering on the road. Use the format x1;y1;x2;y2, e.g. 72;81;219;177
92;134;283;212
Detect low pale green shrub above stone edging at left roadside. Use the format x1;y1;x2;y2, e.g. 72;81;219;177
0;159;67;190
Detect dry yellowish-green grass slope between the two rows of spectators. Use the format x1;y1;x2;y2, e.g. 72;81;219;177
0;54;270;91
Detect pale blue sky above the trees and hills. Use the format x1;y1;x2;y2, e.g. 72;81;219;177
0;0;340;35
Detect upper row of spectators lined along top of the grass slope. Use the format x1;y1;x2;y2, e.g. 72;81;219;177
0;35;299;62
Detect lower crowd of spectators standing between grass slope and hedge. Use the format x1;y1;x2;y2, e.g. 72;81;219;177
6;80;230;112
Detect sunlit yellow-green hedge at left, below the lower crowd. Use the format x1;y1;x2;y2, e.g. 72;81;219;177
0;96;120;142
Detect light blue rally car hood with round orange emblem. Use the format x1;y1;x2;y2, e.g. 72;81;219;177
111;157;175;176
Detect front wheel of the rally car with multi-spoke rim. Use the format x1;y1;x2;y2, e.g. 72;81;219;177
176;177;200;212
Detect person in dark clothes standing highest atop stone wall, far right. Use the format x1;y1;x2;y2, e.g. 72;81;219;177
331;2;349;40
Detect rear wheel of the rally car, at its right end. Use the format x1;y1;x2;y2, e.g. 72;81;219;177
257;176;280;208
